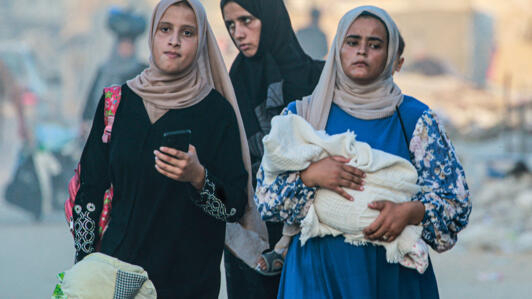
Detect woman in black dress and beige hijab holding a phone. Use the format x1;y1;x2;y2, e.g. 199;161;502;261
73;0;267;298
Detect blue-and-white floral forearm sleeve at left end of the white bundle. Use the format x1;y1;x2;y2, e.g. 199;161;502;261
255;166;316;224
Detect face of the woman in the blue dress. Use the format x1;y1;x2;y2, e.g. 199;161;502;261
340;16;388;85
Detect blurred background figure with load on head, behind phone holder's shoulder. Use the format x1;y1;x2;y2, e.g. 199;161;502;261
82;7;148;129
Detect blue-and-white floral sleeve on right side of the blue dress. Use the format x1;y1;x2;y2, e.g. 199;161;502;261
410;110;471;252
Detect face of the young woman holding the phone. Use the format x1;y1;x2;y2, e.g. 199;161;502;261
153;4;198;74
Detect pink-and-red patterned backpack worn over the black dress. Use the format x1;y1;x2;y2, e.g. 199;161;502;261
65;86;122;243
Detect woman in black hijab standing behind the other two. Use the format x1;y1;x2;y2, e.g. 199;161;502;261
221;0;324;298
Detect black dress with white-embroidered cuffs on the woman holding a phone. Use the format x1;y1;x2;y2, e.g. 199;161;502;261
74;85;247;298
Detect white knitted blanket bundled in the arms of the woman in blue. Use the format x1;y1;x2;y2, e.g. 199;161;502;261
262;114;428;273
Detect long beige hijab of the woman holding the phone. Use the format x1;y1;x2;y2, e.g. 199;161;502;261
127;0;268;267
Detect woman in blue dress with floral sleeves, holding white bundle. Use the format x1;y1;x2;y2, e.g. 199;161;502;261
255;6;471;299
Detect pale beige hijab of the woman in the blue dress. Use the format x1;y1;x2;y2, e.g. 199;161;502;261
297;6;403;130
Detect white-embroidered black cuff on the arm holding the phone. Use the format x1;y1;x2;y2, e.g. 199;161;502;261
194;169;236;221
